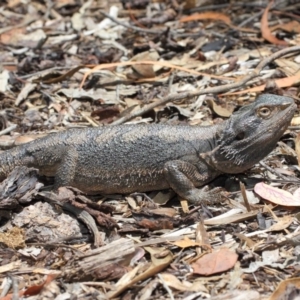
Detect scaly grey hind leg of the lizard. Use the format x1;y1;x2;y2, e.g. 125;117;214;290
53;147;78;191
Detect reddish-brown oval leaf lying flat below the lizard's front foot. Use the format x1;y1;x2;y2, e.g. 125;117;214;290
192;248;238;276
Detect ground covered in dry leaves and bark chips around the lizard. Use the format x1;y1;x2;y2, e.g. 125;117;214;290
0;0;300;300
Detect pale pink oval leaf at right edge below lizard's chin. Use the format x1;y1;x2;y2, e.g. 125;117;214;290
254;182;300;206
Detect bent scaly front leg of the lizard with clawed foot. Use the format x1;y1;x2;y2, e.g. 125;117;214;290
164;160;220;204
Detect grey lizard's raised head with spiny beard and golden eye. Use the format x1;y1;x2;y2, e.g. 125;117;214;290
203;94;296;173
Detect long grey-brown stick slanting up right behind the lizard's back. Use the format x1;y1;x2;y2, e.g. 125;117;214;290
112;46;300;125
